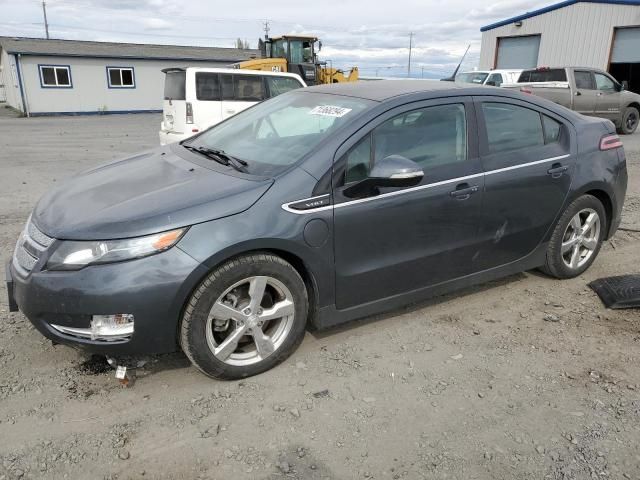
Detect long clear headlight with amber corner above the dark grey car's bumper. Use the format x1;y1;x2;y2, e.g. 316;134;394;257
46;228;187;270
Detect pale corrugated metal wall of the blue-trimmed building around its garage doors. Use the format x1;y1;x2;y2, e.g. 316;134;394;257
479;3;640;69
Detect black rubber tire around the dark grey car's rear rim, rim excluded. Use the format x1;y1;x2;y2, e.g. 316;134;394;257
542;195;609;279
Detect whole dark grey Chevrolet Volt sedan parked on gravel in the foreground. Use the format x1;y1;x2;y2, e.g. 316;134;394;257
7;81;627;379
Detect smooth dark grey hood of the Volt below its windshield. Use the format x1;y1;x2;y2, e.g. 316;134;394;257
32;146;273;240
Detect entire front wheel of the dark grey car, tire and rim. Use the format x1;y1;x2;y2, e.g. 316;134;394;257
180;253;309;380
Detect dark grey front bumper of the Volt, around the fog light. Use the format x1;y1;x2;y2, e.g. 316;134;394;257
6;247;207;355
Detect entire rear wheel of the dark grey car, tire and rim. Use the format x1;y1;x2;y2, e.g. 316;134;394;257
542;195;607;278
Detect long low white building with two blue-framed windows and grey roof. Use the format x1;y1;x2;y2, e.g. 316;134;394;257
0;37;257;116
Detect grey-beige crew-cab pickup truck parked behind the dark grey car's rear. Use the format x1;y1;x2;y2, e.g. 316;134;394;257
502;67;640;134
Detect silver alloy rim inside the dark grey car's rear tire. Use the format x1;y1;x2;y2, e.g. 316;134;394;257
561;208;600;270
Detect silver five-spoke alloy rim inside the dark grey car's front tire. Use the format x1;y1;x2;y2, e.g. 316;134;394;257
206;276;295;366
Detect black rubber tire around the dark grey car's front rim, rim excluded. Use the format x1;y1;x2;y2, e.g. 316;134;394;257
179;253;309;380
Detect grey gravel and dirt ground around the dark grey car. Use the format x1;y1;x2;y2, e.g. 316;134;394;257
0;109;640;480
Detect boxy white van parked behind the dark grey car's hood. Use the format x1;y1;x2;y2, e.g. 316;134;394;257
160;67;306;145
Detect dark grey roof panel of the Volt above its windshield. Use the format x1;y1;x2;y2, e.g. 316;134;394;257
304;80;469;102
